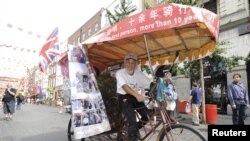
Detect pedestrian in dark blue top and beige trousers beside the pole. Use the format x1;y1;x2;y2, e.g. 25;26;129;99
189;82;202;126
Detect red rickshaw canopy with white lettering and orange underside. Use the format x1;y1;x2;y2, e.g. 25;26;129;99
82;3;219;70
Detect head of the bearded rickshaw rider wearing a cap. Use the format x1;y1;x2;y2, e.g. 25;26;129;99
124;53;138;75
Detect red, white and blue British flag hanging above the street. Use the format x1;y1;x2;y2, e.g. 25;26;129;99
39;28;60;72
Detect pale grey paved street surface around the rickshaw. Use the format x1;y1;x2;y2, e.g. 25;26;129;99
0;105;250;141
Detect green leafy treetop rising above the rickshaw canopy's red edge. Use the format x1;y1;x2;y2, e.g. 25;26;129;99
106;0;137;25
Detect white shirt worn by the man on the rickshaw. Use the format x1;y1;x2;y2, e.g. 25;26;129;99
116;69;150;95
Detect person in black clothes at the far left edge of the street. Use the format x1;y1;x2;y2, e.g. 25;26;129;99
3;84;17;120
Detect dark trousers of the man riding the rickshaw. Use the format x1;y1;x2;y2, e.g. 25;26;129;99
118;94;149;141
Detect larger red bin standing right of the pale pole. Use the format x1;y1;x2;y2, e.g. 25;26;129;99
205;104;218;124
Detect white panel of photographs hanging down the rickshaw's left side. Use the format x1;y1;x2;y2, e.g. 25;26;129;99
60;47;111;139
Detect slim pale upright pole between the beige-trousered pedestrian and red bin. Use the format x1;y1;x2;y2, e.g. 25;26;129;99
199;59;206;124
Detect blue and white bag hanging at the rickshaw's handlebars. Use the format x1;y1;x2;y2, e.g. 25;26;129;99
156;78;177;102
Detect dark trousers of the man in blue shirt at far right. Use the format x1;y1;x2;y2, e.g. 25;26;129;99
232;104;246;125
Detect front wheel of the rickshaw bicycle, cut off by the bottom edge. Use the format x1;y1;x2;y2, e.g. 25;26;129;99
158;124;207;141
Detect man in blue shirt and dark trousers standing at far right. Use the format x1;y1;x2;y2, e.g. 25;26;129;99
227;73;249;125
